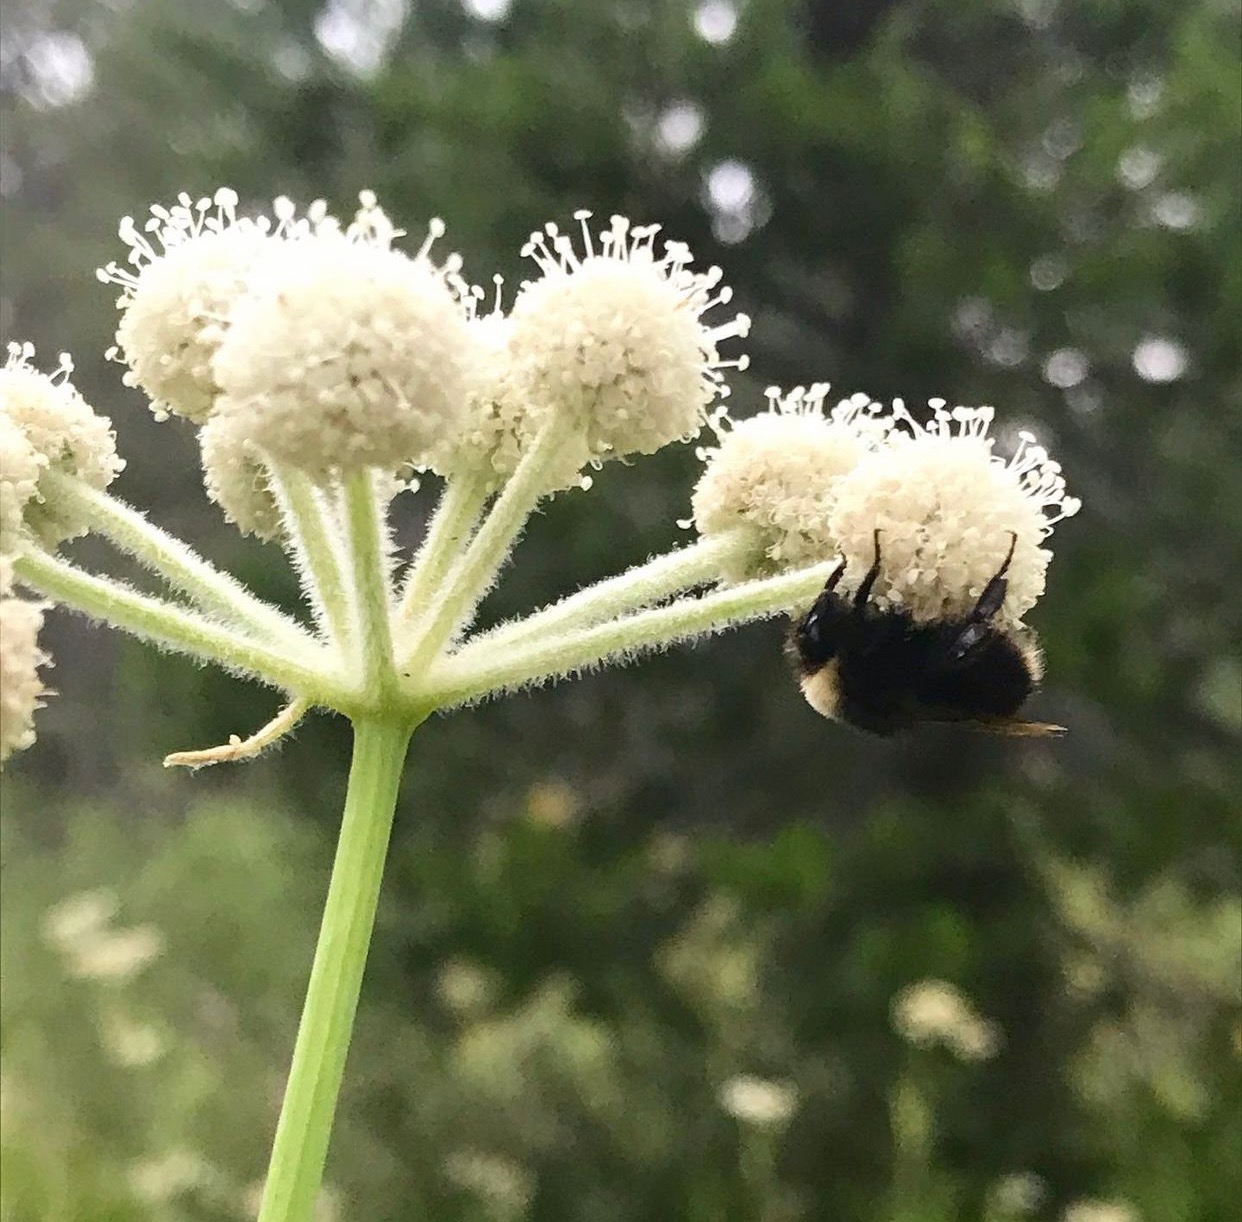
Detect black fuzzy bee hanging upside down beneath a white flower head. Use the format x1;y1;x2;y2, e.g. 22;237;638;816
787;530;1064;736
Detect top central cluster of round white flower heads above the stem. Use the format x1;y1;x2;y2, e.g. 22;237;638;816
99;189;748;536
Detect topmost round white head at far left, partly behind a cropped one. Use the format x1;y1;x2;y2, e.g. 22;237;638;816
0;344;124;546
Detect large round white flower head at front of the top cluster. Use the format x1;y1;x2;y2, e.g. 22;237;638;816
211;195;471;477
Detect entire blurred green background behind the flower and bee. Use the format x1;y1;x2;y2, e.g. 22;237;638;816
0;0;1242;1222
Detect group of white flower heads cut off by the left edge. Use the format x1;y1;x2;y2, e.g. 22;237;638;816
0;344;123;764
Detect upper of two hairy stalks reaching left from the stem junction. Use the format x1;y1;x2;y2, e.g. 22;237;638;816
40;471;311;646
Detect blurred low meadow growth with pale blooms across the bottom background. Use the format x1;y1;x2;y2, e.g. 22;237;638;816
0;784;1242;1222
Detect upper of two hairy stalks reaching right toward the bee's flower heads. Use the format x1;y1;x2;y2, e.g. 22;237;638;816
472;532;750;647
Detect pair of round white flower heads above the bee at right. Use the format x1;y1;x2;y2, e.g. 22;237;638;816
693;385;1079;625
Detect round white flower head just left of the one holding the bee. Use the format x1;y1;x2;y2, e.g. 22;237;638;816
692;382;891;579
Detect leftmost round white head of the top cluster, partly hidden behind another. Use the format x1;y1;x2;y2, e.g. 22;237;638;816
98;188;325;422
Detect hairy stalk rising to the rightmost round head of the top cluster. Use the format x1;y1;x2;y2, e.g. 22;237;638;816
401;416;565;676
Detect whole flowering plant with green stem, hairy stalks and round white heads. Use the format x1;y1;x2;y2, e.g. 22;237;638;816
0;190;1077;1222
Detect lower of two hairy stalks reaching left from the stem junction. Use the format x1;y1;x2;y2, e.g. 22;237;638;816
14;551;345;708
